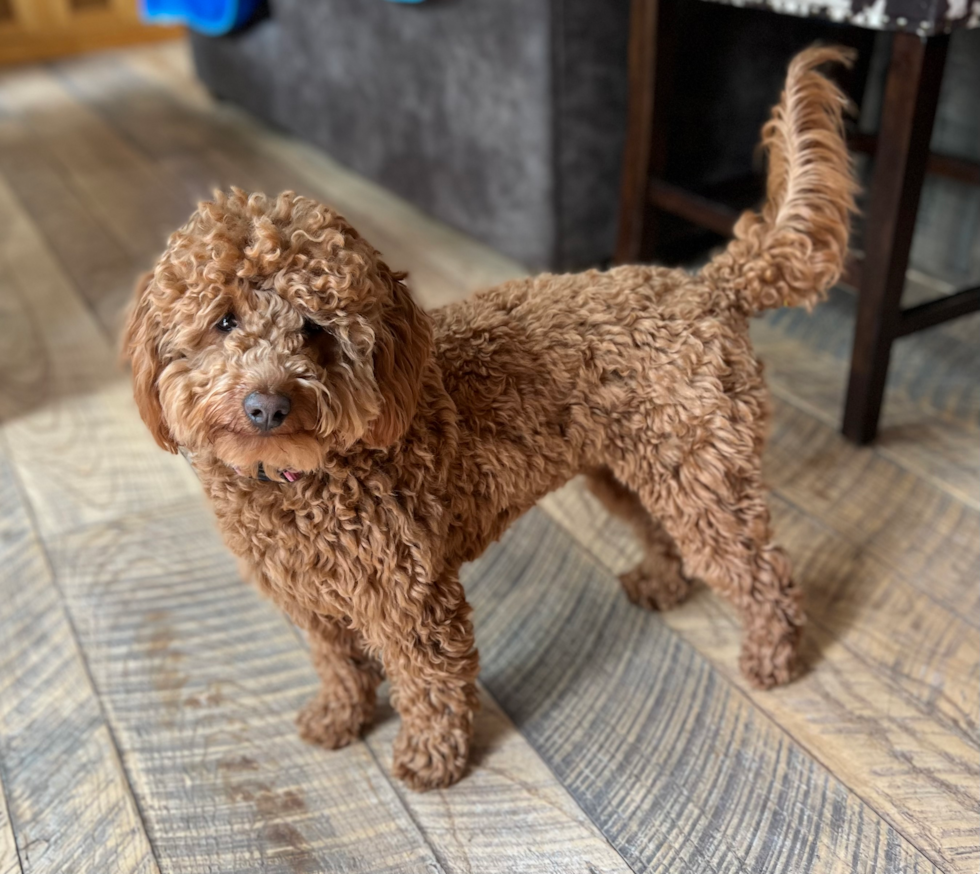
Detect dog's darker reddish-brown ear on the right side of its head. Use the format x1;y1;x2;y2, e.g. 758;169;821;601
362;262;433;449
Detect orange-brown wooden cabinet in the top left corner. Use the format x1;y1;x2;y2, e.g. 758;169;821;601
0;0;182;64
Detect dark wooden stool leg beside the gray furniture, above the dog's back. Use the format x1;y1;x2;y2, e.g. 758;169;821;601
614;0;673;264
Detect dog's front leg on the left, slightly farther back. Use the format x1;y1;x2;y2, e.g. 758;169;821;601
296;616;382;749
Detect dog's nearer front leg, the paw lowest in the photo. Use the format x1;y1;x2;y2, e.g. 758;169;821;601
383;573;479;791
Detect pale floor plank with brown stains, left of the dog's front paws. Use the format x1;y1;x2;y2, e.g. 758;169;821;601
50;504;441;874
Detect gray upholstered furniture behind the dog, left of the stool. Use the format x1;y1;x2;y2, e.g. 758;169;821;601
193;0;629;269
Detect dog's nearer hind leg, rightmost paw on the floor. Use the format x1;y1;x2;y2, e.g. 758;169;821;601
616;433;804;688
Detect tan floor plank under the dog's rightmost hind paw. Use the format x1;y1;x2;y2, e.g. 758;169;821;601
540;460;980;872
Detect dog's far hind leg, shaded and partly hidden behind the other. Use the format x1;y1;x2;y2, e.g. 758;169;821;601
586;468;691;610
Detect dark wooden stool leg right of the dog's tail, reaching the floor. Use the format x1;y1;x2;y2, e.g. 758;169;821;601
842;33;949;444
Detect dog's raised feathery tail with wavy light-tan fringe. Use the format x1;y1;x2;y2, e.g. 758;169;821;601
705;46;857;314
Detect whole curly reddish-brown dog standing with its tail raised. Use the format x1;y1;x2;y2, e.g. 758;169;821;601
124;47;856;790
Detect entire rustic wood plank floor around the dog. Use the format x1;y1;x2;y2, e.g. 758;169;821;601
0;43;980;874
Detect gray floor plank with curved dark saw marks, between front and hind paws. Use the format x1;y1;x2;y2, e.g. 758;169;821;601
466;510;937;874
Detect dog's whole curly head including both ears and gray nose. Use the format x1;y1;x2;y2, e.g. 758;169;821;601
124;190;432;471
